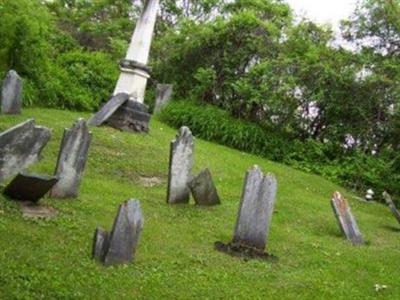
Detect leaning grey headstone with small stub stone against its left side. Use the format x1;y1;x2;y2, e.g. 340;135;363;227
92;199;144;266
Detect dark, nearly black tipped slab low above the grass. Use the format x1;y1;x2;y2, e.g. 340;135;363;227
3;173;58;202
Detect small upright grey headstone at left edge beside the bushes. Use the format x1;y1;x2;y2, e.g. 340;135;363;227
1;70;22;114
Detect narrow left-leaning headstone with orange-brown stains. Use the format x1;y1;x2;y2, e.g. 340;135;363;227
331;192;364;245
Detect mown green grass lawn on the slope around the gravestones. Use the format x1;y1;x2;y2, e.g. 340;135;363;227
0;109;400;299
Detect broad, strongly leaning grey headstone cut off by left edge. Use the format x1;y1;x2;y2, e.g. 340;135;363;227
0;119;51;182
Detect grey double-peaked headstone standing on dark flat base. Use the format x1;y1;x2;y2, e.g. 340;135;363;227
215;166;277;259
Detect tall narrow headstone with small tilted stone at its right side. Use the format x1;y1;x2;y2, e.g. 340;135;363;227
167;126;194;204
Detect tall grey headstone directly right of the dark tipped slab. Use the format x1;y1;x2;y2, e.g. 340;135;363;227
50;119;92;198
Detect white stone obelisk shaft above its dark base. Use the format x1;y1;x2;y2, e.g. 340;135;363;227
113;0;159;103
